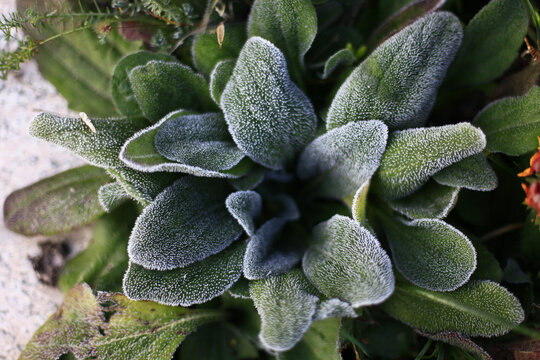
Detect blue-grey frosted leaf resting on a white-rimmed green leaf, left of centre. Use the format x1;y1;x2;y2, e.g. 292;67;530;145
154;113;244;171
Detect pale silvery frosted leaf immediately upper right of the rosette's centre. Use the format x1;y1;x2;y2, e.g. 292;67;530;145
297;120;388;199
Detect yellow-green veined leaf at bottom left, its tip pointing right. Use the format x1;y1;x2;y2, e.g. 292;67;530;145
91;293;221;360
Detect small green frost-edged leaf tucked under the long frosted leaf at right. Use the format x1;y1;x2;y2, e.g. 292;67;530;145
433;154;499;191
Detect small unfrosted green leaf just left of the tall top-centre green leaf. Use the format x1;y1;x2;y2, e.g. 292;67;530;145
191;23;246;78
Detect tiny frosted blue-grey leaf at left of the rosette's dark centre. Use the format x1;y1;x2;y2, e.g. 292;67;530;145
225;190;262;236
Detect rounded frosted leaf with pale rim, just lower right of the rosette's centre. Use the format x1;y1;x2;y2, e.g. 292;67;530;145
302;215;394;308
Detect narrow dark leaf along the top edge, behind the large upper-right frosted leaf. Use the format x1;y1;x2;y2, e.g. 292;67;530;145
368;0;446;48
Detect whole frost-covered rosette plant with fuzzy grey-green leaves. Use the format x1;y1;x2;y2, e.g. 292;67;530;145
5;0;538;359
